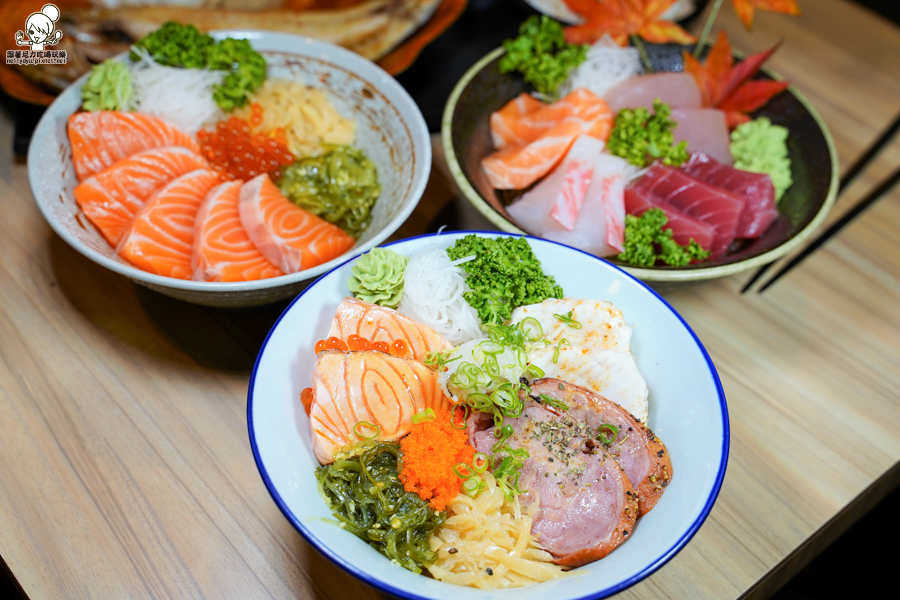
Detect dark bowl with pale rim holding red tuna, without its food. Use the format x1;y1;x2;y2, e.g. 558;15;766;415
441;44;838;282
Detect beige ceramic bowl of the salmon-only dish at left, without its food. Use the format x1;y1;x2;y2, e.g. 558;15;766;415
28;31;431;307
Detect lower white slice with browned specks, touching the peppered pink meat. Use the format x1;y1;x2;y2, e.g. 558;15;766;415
528;346;649;423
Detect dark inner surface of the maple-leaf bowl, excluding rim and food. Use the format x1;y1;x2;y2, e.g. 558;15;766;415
451;44;835;270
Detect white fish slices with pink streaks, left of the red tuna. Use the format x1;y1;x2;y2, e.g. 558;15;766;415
508;136;627;256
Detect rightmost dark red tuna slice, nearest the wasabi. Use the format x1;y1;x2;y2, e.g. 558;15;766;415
679;152;778;239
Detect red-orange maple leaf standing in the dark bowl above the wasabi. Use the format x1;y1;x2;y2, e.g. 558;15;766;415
683;31;791;128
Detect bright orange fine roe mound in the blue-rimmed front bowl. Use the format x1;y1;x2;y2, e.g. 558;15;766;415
400;411;475;511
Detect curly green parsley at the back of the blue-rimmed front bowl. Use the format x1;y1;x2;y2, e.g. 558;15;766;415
447;234;563;323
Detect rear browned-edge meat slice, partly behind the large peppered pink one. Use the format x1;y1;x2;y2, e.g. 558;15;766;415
531;378;672;516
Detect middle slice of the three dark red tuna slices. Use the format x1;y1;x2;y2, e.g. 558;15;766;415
635;162;744;258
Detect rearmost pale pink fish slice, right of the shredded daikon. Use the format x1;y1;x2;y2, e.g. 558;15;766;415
604;73;700;112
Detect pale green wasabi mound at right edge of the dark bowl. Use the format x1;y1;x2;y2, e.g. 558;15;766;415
730;117;794;200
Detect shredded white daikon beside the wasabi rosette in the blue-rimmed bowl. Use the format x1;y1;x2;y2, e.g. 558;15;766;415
397;248;485;345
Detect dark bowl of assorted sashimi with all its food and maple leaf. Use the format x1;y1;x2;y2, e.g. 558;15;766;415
443;16;837;281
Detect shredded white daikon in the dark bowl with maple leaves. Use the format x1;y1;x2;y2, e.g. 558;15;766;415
560;35;643;97
